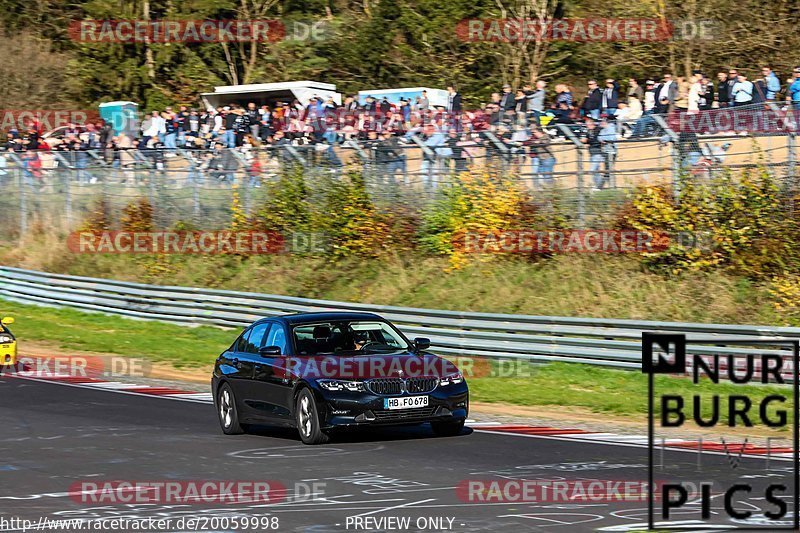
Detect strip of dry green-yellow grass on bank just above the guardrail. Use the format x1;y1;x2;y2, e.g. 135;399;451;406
0;236;798;325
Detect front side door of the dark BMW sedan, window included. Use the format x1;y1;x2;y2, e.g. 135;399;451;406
253;322;292;421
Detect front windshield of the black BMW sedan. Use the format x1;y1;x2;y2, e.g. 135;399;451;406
292;320;409;355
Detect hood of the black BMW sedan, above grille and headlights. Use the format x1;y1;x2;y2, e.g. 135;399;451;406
284;352;458;380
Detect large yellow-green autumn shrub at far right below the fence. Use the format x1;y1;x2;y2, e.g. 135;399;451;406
618;169;800;278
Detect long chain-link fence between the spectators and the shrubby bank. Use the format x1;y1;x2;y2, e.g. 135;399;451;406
0;128;796;237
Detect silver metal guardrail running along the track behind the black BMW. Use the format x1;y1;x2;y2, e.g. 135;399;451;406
0;267;800;368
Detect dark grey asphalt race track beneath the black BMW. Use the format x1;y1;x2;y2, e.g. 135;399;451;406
0;377;791;533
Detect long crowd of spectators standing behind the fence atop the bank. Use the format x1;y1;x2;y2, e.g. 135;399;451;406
0;66;800;189
